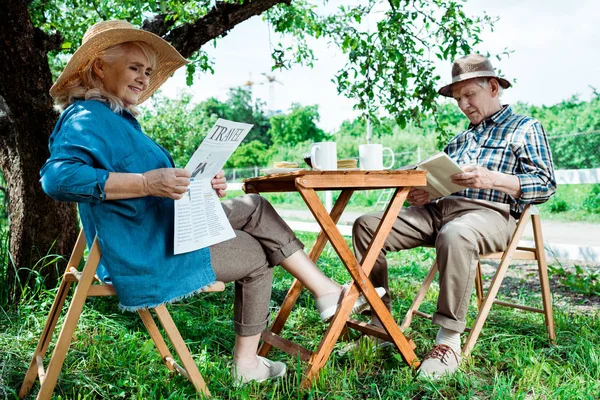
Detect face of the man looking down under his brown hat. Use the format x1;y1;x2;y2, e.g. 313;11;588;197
452;79;500;125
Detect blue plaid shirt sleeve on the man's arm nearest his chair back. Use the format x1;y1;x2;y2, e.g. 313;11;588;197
517;121;556;205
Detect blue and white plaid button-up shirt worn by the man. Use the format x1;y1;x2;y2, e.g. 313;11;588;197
444;106;556;215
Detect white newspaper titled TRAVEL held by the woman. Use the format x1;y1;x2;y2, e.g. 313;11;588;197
174;118;252;254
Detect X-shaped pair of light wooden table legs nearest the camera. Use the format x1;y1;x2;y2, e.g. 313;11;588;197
298;185;419;387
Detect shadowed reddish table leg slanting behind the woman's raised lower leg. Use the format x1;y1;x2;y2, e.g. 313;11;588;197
258;190;353;357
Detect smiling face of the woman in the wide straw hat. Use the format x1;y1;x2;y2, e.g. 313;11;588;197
95;46;152;107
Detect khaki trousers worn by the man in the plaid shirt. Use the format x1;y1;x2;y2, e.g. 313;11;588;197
352;196;516;332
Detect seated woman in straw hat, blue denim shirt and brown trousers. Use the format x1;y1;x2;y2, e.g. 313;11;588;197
41;21;384;383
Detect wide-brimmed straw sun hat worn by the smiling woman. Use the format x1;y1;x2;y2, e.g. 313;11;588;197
50;21;188;104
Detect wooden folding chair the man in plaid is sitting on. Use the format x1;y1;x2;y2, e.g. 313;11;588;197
400;205;556;356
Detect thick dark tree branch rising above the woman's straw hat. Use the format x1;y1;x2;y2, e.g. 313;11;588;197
143;0;291;58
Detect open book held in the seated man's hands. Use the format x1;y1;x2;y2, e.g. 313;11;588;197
398;152;466;199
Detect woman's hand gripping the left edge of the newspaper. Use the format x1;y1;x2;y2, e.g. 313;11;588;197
142;168;191;200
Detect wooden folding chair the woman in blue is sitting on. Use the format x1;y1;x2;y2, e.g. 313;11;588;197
19;230;225;399
